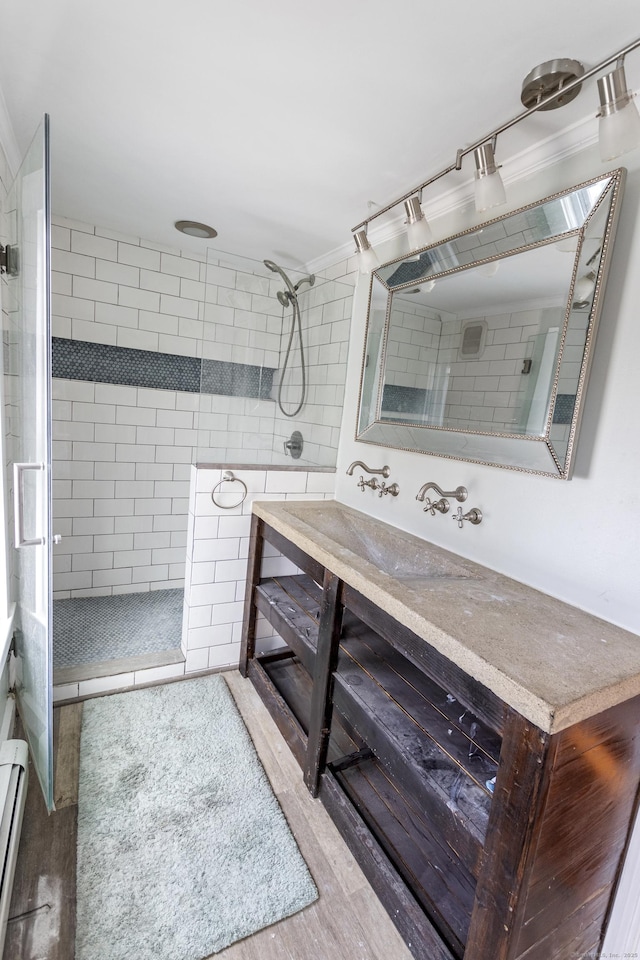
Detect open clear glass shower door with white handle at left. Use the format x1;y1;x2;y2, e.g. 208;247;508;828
5;116;53;810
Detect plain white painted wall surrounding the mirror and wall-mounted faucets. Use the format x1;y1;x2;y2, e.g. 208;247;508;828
336;149;640;642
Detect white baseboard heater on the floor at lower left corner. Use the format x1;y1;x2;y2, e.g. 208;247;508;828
0;740;29;957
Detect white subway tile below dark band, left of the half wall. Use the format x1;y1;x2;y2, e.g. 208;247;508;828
53;378;195;599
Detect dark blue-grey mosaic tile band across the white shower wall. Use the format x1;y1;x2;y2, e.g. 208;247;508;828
52;337;275;400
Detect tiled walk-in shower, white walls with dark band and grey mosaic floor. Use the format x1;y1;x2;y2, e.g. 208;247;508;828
52;219;353;676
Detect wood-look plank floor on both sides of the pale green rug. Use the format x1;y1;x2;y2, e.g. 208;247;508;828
4;672;411;960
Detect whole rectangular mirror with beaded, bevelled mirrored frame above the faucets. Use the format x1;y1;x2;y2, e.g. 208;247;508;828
356;168;626;480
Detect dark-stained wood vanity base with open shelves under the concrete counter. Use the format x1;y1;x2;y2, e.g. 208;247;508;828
240;514;640;960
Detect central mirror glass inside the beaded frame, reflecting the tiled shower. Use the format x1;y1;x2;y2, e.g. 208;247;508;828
380;244;575;436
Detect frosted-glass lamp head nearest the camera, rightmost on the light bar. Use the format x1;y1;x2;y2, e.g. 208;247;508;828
597;57;640;160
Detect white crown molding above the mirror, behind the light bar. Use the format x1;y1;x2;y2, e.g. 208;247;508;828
306;107;598;273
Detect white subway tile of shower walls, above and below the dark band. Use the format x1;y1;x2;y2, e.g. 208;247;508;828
52;218;354;598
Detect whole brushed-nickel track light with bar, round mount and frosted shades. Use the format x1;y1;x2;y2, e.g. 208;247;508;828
352;38;640;255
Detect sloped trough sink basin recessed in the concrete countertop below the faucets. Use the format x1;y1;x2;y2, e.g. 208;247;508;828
278;500;478;587
